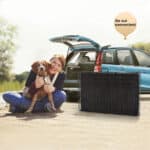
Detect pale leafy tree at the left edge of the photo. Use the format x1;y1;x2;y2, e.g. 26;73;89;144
0;18;17;81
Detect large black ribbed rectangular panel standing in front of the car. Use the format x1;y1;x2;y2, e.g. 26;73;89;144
80;72;139;116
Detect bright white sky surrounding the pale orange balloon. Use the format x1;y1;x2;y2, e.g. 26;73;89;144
0;0;150;74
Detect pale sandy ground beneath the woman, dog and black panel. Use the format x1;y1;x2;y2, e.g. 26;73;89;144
0;101;150;150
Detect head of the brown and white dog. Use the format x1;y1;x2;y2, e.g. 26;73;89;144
31;60;51;76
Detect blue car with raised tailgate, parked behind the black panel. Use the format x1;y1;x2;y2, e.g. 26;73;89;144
50;35;150;99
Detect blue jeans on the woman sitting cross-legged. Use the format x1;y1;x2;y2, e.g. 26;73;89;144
3;90;66;112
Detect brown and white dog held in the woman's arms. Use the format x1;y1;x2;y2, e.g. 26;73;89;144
25;61;56;113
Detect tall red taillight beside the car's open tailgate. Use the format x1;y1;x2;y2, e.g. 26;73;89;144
94;51;102;72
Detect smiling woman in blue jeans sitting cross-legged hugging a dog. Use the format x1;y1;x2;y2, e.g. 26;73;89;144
3;55;66;112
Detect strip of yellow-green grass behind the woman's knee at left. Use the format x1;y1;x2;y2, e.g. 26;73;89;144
0;81;24;93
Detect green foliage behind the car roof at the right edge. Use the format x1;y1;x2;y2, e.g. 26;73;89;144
132;42;150;52
